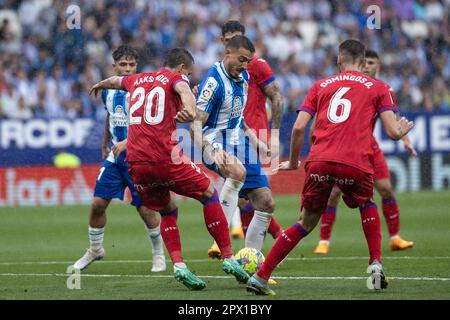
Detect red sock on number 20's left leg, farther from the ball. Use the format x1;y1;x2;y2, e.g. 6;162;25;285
160;208;183;264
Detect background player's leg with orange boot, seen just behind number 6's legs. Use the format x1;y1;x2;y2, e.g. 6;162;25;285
314;186;342;254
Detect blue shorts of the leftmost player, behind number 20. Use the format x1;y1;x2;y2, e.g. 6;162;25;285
94;160;143;207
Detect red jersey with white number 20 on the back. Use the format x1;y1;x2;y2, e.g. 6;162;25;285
122;68;189;162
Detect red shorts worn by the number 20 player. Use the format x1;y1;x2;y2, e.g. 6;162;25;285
128;159;210;211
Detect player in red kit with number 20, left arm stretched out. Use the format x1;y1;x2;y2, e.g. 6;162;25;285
91;48;248;290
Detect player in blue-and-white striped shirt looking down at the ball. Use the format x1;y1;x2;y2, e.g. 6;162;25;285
191;36;275;262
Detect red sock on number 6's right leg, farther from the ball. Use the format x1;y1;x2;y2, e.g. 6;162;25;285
359;201;381;264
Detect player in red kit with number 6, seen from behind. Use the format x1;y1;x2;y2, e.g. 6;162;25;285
247;40;413;295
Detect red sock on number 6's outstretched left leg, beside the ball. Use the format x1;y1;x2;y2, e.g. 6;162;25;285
257;223;308;280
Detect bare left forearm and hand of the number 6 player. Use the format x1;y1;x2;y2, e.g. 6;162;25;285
278;111;311;170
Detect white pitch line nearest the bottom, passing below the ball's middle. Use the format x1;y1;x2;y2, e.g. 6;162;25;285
0;273;450;281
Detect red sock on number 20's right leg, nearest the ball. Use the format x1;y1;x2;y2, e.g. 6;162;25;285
203;190;233;258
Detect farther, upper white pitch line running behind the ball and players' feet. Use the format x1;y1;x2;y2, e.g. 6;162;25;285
0;256;450;266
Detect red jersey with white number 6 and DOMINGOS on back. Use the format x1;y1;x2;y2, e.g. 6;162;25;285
297;71;397;174
